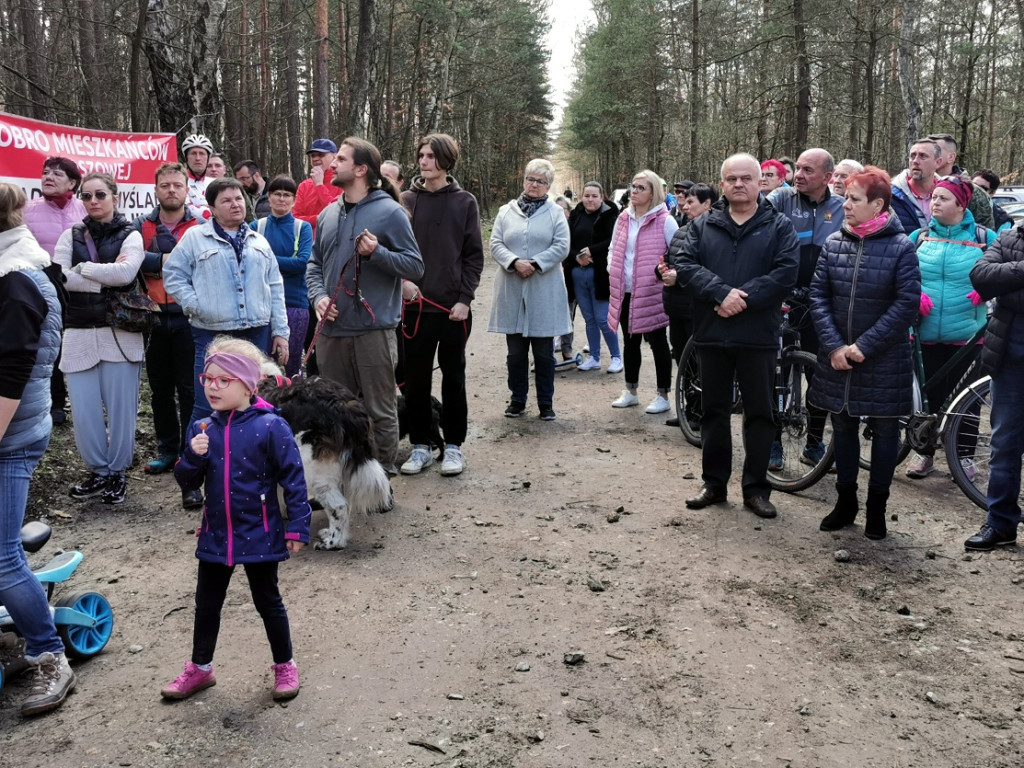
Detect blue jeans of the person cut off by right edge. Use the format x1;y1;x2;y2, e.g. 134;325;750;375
987;357;1024;534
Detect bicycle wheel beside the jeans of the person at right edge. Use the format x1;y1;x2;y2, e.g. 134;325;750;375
942;376;992;509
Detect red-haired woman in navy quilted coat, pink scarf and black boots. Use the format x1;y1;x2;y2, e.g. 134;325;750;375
807;166;921;539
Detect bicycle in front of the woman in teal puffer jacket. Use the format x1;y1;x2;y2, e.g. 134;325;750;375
860;326;992;509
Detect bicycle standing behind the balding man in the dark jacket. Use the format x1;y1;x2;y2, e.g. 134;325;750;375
675;294;835;494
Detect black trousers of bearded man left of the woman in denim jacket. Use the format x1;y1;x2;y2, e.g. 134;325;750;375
145;312;196;457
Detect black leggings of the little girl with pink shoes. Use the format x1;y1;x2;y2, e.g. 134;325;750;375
193;560;292;664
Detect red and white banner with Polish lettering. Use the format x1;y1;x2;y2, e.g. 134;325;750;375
0;112;178;220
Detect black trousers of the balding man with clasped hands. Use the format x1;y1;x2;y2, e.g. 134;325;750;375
697;346;777;499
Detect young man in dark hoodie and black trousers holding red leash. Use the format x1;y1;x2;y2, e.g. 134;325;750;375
401;133;483;475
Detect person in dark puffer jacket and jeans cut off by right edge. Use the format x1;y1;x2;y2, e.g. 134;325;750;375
964;226;1024;552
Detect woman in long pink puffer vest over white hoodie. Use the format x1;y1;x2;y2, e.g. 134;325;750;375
608;170;679;414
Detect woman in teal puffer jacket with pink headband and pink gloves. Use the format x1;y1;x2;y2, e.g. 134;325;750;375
906;176;995;477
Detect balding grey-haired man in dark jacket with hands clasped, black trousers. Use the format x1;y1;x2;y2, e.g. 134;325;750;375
668;154;800;517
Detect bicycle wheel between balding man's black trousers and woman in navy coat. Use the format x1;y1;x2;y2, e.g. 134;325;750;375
768;349;836;494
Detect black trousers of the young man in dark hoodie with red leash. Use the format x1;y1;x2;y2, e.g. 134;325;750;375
404;308;473;445
